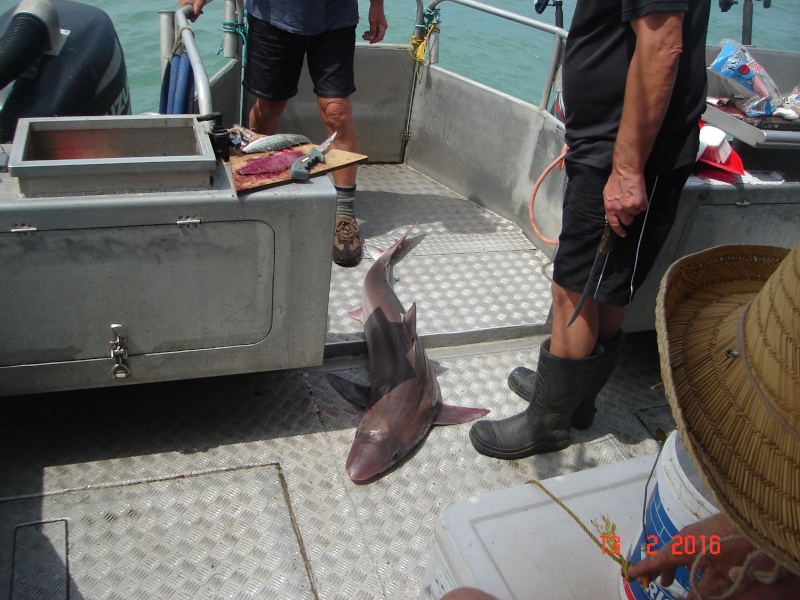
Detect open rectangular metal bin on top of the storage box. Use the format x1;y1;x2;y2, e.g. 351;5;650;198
8;115;216;195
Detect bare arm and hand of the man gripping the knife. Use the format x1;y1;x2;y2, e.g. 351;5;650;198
603;12;683;237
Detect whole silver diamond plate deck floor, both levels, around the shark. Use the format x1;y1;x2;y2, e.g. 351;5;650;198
0;166;674;600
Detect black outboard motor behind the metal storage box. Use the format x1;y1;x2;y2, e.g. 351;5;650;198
0;0;131;143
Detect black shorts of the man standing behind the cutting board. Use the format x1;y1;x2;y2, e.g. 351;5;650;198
242;17;356;100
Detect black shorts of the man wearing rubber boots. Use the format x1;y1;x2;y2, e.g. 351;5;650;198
553;161;692;306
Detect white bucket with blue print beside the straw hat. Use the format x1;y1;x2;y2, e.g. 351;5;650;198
620;431;719;600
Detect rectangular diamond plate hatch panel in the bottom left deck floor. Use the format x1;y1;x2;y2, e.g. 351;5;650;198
0;465;316;600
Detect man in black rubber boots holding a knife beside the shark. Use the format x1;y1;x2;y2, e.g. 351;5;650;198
470;0;710;459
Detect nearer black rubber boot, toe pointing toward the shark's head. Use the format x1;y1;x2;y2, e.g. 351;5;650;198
469;340;603;460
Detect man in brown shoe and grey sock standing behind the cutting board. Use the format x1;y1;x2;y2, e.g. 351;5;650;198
179;0;387;266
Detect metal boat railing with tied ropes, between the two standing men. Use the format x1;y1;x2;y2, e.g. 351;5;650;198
414;0;567;109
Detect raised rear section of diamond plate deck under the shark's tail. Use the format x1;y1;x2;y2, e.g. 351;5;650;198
327;165;552;344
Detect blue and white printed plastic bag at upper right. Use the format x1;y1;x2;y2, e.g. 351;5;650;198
708;40;781;117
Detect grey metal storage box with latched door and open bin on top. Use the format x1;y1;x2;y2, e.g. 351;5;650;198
0;116;336;395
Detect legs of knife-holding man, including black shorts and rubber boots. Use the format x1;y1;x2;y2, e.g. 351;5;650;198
470;162;690;459
